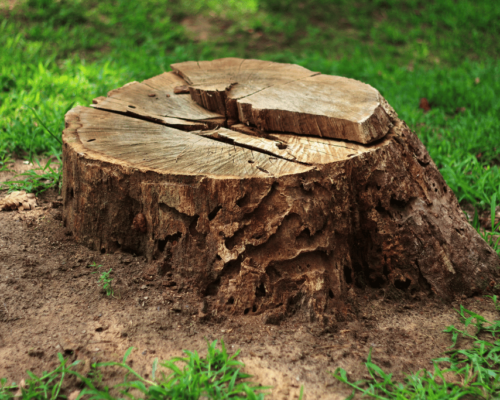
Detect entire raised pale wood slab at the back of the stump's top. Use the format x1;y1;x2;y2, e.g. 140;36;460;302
172;58;391;143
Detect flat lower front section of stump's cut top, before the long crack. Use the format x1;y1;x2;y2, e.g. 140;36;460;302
67;107;311;178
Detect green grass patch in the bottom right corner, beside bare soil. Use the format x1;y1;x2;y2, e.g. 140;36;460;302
333;296;500;400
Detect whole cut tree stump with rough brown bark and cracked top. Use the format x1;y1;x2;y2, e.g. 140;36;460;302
63;58;500;321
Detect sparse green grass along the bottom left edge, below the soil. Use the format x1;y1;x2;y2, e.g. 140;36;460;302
0;341;268;400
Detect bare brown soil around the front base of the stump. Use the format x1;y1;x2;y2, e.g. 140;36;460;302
0;188;500;399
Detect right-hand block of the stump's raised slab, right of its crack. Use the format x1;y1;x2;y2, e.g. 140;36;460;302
238;75;391;143
